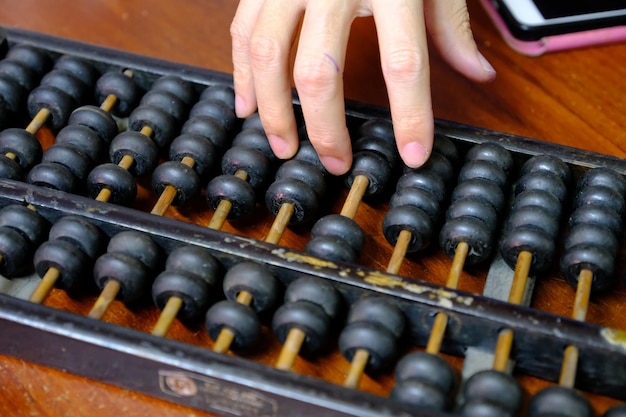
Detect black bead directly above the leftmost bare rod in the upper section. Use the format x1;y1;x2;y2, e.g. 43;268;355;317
28;85;77;130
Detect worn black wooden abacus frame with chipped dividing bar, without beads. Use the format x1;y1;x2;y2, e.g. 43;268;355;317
0;29;626;417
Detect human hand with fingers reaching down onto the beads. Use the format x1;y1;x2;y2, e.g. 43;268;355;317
231;0;495;175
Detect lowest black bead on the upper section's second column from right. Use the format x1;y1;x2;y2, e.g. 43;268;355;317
500;226;556;275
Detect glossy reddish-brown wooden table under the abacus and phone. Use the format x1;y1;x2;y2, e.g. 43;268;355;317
0;0;626;417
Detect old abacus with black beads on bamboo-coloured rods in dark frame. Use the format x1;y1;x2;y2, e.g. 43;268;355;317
0;26;626;417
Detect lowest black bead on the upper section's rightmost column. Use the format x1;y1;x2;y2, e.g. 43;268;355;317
561;242;615;292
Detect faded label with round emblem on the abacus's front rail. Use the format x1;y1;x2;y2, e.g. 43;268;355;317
159;370;278;417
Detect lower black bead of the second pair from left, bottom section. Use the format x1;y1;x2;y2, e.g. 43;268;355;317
33;239;91;290
